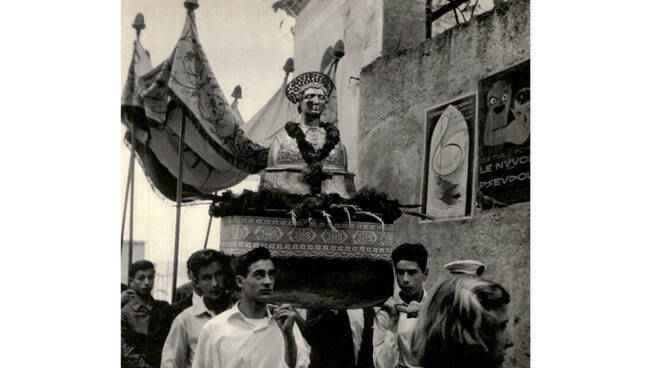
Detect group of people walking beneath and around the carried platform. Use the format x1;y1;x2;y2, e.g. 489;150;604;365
121;243;513;368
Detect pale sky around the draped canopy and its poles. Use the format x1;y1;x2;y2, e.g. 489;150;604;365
116;0;295;270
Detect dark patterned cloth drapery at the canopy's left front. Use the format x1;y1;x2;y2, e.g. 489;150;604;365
122;11;268;199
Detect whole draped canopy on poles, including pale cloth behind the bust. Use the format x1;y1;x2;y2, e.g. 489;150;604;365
121;11;339;201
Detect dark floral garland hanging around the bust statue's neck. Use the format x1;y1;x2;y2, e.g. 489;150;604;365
285;121;340;195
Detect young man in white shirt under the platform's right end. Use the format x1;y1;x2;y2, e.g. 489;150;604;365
373;243;428;368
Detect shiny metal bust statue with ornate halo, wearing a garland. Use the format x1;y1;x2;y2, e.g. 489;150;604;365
259;72;355;198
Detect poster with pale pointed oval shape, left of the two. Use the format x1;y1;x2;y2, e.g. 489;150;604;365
422;94;477;221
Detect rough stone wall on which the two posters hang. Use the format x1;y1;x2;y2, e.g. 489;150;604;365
356;0;530;367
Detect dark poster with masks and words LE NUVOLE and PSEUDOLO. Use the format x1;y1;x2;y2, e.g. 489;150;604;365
478;60;530;208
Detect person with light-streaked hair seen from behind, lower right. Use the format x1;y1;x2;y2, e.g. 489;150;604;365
412;275;510;368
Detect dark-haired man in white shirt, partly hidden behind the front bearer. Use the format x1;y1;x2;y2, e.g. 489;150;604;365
160;249;231;368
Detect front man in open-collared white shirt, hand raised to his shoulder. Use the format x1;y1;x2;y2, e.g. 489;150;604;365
193;248;309;368
